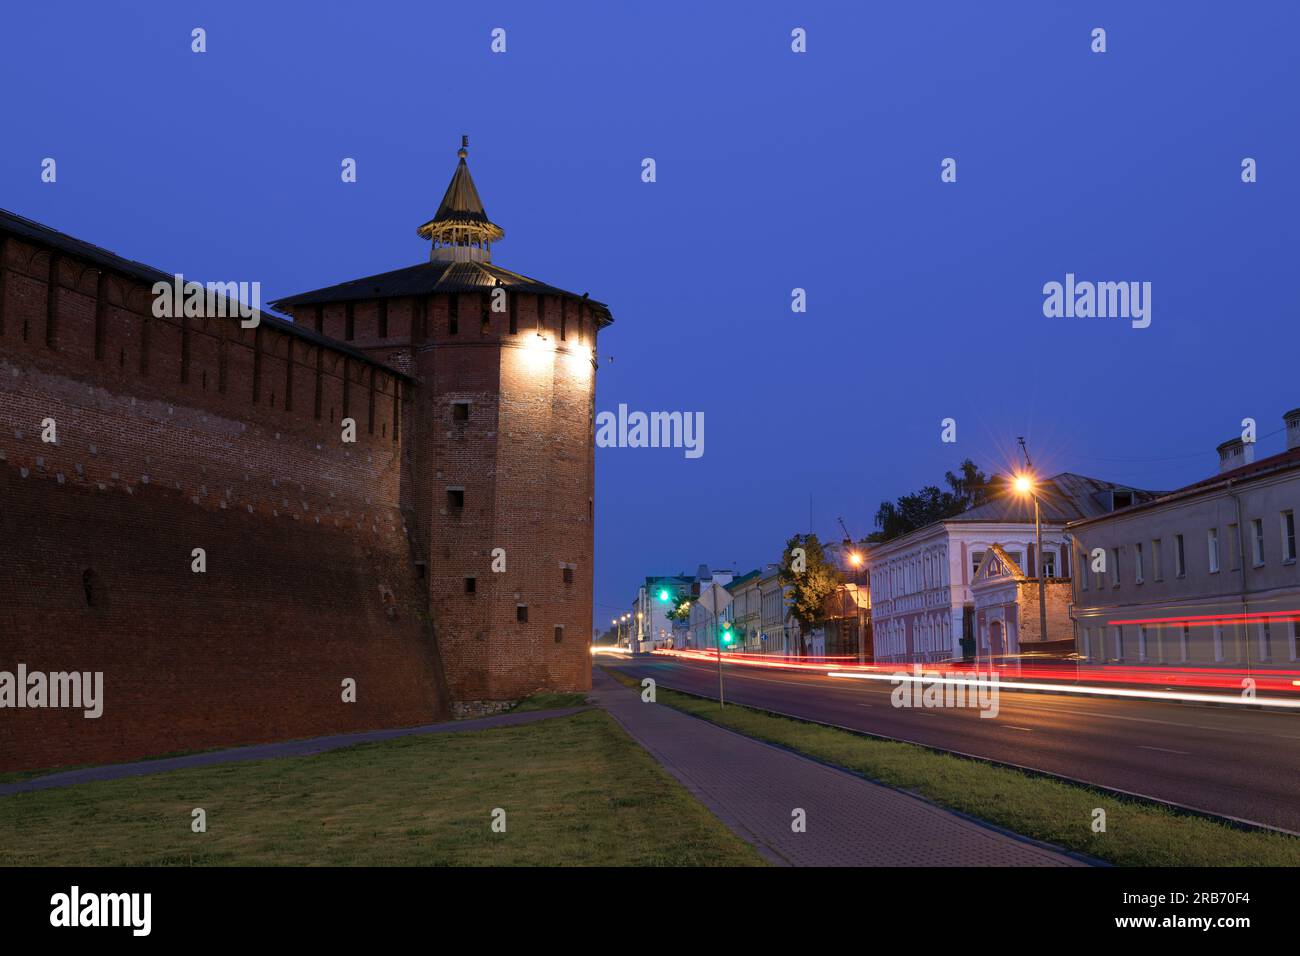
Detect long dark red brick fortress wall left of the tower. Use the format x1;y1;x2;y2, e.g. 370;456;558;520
0;232;452;771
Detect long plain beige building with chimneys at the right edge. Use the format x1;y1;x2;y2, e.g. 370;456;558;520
1069;418;1300;666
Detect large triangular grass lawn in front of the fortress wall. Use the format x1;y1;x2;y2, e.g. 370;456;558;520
0;710;763;866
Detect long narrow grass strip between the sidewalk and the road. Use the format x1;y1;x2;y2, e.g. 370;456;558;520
607;669;1300;866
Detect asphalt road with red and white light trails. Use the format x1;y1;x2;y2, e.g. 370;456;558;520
598;657;1300;832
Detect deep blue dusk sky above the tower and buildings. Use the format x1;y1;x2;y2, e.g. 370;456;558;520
0;0;1300;622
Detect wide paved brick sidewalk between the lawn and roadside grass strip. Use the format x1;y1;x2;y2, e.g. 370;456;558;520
592;667;1087;866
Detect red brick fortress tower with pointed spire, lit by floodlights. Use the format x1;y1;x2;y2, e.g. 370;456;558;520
276;140;612;713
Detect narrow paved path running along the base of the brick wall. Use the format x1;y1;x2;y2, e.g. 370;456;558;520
0;708;588;796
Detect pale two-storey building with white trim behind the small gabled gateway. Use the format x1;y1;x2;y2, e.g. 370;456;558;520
867;472;1156;662
